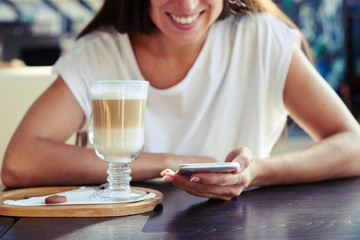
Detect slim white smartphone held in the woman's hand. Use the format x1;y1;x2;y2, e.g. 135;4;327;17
178;162;240;175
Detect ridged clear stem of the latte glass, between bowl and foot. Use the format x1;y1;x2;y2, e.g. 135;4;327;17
107;163;131;192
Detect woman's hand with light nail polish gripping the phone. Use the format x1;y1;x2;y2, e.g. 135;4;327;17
161;147;255;200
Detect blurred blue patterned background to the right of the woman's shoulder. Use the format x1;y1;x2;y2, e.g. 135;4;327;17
275;0;360;121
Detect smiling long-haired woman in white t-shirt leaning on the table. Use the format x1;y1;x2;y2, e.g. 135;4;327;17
2;0;360;200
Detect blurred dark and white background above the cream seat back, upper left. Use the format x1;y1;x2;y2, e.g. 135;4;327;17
0;0;102;66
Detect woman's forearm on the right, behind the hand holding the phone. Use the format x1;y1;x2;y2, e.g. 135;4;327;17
251;132;360;186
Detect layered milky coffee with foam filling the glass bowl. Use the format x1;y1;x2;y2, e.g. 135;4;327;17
92;86;146;163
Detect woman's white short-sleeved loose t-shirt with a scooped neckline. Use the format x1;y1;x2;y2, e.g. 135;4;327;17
54;13;300;161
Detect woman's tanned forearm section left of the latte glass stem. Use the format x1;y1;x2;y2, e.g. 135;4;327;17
2;139;107;187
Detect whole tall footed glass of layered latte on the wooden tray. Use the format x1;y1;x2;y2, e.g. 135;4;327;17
89;80;149;201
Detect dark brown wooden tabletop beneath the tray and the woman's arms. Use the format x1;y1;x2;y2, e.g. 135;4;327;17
0;178;360;240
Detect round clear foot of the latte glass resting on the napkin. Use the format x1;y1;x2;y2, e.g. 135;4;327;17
94;188;147;202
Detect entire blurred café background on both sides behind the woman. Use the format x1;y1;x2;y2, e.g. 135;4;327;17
0;0;360;183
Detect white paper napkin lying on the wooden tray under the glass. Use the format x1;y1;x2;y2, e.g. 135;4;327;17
4;187;156;206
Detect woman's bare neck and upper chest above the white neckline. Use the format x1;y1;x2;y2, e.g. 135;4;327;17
130;30;206;89
